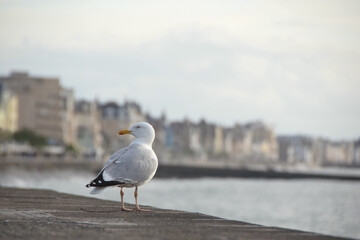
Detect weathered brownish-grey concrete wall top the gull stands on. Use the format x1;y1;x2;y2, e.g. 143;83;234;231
0;187;350;240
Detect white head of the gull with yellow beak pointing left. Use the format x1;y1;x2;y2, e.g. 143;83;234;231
119;122;155;145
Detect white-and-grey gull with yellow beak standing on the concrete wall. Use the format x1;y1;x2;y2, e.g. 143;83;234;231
86;122;158;211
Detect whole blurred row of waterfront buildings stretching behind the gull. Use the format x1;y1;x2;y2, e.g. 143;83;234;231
0;72;360;166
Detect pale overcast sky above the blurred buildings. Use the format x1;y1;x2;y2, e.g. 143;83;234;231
0;0;360;139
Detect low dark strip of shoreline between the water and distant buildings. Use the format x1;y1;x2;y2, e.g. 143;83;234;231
0;160;360;181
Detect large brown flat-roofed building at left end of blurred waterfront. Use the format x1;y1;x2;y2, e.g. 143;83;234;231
0;72;63;141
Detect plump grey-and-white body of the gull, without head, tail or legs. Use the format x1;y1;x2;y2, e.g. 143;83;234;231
103;145;158;184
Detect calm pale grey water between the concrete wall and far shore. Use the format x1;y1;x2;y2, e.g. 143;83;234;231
0;170;360;239
